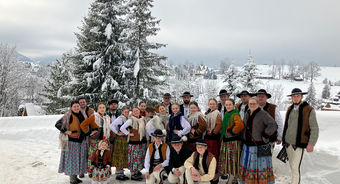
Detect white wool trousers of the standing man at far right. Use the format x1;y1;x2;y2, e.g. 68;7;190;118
287;145;304;184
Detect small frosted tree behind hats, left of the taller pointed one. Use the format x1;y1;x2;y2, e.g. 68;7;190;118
223;64;240;99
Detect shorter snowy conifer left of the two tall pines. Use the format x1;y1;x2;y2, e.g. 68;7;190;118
41;54;72;114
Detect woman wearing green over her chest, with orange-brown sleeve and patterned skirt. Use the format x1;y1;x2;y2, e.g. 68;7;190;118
217;99;244;184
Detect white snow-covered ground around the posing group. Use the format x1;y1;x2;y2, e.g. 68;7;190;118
0;111;340;184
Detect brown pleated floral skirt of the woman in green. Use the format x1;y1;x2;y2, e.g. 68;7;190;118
217;140;241;176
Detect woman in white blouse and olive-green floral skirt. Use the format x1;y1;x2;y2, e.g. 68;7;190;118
110;106;130;181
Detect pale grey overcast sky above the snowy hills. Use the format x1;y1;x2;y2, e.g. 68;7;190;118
0;0;340;66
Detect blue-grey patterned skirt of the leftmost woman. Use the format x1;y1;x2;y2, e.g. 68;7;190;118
58;140;87;176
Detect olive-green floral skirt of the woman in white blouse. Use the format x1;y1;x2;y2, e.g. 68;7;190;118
112;136;129;171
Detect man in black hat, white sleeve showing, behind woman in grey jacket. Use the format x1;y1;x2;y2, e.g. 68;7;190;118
256;89;283;152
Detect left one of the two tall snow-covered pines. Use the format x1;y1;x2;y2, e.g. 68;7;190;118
72;0;129;105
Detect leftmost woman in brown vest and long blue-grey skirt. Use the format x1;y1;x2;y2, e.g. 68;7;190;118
55;101;99;184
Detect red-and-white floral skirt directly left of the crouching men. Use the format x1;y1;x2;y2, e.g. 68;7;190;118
128;143;146;173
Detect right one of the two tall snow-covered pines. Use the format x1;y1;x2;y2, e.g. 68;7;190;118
126;0;166;102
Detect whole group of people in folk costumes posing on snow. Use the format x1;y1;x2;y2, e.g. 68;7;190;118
56;88;319;184
